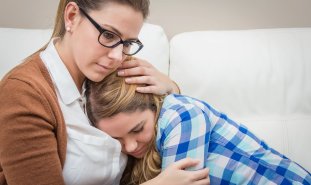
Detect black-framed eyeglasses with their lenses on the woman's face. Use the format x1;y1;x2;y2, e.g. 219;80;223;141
79;7;144;56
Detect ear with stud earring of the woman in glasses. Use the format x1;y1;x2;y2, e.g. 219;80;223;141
64;2;81;33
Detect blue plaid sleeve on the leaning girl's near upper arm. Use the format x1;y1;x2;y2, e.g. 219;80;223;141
159;104;211;170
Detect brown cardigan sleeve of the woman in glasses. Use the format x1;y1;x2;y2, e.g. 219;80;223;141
0;79;64;185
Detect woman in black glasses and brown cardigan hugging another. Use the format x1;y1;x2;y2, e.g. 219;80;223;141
0;0;208;185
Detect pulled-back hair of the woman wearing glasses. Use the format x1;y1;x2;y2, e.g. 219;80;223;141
30;0;150;57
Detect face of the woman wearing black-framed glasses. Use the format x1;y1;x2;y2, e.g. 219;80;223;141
66;3;143;82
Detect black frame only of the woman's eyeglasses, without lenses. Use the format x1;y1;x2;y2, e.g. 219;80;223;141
79;7;144;56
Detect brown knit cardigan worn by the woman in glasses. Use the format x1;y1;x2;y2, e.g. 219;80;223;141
0;54;67;185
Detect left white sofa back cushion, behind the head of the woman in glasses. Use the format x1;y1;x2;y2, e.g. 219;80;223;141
0;23;169;79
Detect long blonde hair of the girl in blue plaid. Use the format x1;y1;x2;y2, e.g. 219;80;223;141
86;72;163;184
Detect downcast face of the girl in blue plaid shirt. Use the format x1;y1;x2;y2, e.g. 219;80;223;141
97;110;155;158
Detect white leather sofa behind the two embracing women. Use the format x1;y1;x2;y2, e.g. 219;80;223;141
0;24;311;171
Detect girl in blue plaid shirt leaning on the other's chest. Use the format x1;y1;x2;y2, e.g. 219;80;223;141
86;71;311;184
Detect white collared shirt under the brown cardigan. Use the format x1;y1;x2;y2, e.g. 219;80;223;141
40;39;127;185
